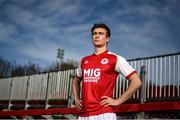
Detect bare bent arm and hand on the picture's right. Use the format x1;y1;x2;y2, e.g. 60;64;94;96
101;73;142;107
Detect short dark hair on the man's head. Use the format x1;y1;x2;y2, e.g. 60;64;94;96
91;23;111;37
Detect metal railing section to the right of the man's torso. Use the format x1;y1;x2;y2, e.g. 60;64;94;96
114;53;180;101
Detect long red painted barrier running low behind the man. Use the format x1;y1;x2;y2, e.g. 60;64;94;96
0;101;180;116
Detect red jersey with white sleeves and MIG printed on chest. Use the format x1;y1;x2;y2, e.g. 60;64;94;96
77;50;136;116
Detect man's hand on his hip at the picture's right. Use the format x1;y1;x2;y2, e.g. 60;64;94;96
100;96;119;107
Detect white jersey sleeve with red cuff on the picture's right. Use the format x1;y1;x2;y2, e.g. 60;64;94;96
115;55;136;79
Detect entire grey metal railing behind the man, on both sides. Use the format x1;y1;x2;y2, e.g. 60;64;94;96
0;53;180;109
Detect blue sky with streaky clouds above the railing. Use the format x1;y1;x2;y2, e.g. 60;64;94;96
0;0;180;67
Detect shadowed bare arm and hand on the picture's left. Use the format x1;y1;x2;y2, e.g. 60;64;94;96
73;76;82;111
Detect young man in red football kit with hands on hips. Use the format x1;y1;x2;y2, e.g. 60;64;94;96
73;23;142;120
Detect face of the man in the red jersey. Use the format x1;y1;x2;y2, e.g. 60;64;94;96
92;28;109;47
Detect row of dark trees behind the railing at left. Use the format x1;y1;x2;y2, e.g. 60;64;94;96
0;57;78;78
